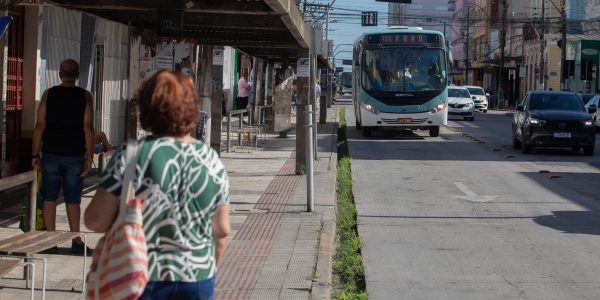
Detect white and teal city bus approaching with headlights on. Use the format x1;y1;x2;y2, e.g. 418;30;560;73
352;26;451;137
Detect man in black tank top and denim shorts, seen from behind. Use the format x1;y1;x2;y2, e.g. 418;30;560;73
31;59;94;253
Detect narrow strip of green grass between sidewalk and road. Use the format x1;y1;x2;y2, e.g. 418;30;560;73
332;109;368;300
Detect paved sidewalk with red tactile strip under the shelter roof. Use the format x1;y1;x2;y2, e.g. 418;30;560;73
0;108;338;299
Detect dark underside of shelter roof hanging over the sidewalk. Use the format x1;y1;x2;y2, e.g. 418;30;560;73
53;0;310;60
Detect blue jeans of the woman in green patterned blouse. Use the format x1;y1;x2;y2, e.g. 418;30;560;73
139;277;215;300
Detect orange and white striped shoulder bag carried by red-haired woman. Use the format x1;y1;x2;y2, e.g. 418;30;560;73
87;141;148;299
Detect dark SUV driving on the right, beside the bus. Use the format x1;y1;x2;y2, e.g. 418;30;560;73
512;91;596;155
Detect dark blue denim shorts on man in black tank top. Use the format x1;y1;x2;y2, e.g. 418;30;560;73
42;153;85;204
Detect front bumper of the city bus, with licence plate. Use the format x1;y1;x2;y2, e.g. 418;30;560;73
360;106;448;129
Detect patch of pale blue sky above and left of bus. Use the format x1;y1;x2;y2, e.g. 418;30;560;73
308;0;388;72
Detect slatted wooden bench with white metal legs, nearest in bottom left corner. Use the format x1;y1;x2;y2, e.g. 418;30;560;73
0;230;87;298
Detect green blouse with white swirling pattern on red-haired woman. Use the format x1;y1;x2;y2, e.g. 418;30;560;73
99;135;229;282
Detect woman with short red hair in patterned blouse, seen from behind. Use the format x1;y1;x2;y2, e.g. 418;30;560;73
84;70;231;299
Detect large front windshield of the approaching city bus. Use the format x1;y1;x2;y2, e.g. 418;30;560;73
361;48;447;92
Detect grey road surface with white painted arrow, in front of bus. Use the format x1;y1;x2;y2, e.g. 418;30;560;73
337;95;600;300
